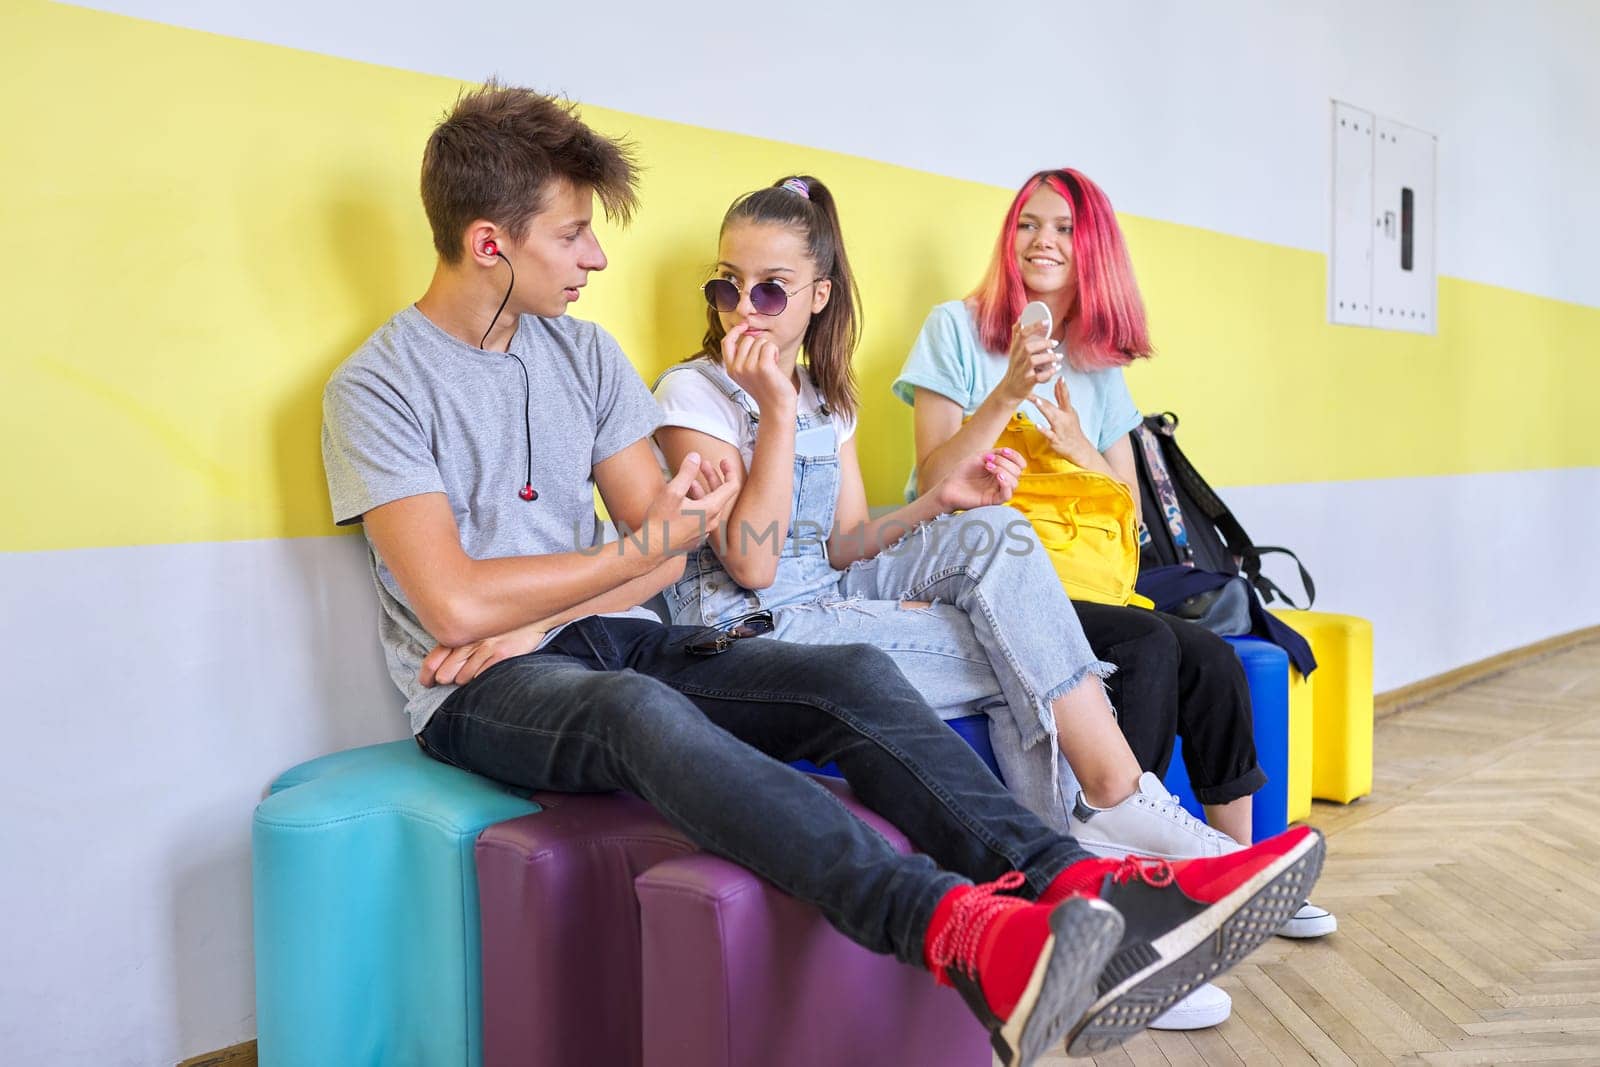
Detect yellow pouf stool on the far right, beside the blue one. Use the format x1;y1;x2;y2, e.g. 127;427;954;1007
1272;609;1373;799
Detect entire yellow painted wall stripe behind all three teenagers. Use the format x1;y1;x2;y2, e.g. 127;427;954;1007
0;0;1600;550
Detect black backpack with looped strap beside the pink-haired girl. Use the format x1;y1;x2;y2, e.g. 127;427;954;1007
1133;411;1317;608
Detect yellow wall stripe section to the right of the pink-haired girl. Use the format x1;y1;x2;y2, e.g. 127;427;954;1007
1123;223;1600;485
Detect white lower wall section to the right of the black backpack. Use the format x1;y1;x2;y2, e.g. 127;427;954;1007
1222;467;1600;693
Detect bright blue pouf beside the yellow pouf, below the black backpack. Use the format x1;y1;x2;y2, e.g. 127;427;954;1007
1166;637;1290;841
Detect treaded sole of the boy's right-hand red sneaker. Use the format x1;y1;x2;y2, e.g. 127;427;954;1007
1067;833;1326;1056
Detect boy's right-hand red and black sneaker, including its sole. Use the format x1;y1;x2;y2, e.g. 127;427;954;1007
1038;827;1325;1056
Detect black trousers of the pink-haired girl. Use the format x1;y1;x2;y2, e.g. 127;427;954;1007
1072;600;1267;805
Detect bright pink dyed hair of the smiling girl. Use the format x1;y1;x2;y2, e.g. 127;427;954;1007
968;168;1155;371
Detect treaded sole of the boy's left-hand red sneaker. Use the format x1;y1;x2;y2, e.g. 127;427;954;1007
989;897;1123;1067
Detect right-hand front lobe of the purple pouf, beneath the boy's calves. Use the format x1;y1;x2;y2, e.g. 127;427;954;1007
635;782;994;1067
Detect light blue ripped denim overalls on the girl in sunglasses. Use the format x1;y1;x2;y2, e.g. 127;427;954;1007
666;362;1115;832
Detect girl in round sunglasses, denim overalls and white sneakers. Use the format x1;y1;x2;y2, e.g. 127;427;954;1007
656;176;1230;1029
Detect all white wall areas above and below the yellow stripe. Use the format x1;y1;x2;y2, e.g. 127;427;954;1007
18;0;1600;1067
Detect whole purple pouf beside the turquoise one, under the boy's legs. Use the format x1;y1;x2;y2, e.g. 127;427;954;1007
477;782;992;1067
